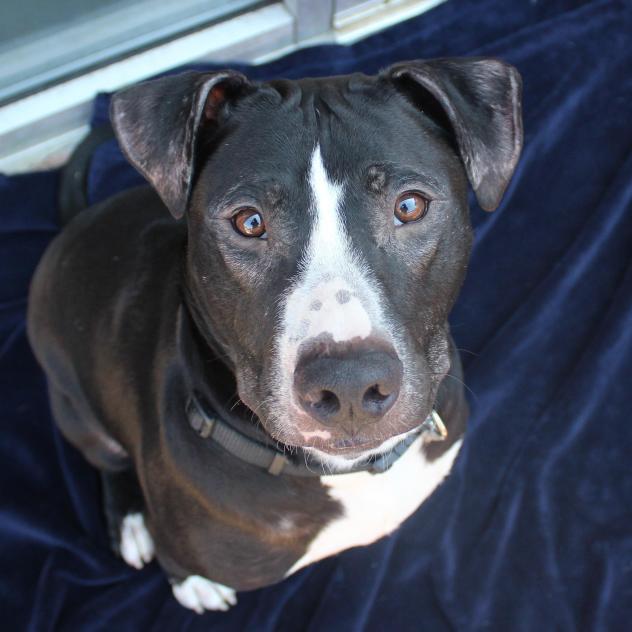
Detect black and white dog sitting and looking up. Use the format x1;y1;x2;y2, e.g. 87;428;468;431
28;58;522;612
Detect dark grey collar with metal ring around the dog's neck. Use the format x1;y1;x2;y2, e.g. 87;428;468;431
186;394;447;476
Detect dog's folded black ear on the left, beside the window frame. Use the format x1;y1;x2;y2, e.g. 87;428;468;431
110;71;254;219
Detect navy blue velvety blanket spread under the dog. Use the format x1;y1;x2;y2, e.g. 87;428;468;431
0;0;632;632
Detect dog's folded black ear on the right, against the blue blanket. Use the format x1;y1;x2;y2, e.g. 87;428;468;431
382;57;522;211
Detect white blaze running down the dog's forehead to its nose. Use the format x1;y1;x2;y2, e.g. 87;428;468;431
277;145;387;420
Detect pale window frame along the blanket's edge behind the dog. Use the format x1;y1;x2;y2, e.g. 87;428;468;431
0;0;446;174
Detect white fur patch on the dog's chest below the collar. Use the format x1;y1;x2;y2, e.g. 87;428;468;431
287;437;461;575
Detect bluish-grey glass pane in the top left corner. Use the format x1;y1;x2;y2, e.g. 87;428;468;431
0;0;266;103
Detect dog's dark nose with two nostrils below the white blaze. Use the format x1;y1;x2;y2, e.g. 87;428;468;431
294;348;402;436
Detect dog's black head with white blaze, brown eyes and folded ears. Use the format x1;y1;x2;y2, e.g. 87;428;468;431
112;59;522;459
